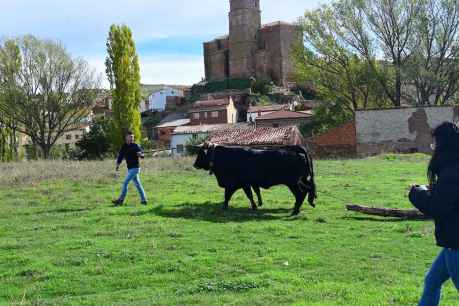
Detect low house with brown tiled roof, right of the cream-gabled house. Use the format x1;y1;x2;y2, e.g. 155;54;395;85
255;110;312;127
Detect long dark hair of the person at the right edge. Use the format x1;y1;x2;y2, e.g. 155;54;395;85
427;122;459;187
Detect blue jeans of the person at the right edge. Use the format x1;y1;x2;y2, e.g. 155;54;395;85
419;249;459;306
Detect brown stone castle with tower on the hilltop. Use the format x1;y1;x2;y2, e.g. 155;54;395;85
204;0;301;86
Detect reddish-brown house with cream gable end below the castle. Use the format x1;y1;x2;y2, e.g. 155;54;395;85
189;96;238;125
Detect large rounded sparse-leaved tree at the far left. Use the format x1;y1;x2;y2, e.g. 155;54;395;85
0;36;98;158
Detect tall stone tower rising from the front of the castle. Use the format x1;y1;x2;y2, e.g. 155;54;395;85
229;0;261;78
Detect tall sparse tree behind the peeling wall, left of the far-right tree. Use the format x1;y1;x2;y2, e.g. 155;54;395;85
334;0;422;106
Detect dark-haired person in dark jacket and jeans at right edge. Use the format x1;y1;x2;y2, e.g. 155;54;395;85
409;122;459;306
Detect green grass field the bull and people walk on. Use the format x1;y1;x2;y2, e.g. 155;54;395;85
0;155;459;306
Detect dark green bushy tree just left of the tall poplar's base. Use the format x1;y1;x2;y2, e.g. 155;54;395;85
76;119;112;159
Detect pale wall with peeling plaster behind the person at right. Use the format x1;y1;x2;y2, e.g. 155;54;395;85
356;106;459;155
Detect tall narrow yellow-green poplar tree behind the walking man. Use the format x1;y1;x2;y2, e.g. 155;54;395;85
105;25;141;148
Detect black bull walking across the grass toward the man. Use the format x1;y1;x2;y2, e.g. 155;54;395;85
194;145;317;215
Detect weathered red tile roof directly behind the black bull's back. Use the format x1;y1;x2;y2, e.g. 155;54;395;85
209;127;304;146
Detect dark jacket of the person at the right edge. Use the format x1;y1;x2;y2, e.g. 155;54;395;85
409;162;459;250
